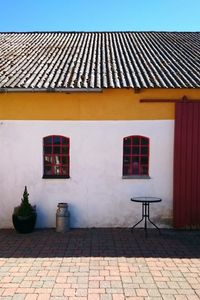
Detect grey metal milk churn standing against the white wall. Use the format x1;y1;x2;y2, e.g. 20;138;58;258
56;203;70;232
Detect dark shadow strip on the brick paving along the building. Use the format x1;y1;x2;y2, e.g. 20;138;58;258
0;228;200;258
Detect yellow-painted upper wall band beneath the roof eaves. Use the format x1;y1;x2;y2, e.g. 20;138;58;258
0;89;200;120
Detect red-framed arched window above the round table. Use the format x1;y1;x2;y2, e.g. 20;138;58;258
123;135;149;178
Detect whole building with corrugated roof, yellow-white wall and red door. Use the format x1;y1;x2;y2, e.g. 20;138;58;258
0;32;200;228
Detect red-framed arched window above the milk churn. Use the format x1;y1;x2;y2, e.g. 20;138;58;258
43;135;69;178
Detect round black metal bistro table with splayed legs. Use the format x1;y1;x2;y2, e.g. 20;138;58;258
131;197;162;236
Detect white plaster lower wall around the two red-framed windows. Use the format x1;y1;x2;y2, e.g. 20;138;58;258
0;120;174;228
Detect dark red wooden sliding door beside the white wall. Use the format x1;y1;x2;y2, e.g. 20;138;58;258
173;102;200;228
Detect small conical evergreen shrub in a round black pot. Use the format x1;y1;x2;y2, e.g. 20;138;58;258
12;186;37;233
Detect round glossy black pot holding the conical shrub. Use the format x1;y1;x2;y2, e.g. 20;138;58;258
12;207;37;233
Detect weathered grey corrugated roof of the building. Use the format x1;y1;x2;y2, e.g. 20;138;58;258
0;32;200;89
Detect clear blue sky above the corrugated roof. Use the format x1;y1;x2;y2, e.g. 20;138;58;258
0;0;200;31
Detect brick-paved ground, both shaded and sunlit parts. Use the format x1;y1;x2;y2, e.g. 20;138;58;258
0;228;200;300
